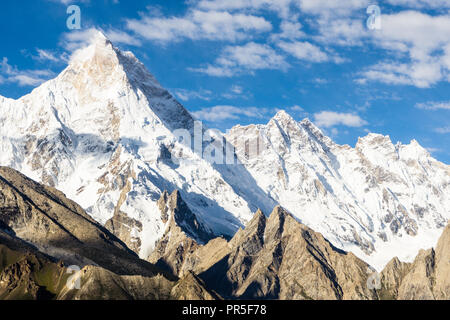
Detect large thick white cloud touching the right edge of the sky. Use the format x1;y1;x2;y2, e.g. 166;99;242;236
359;11;450;88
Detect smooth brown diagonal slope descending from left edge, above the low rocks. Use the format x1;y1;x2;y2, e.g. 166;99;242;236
0;167;165;276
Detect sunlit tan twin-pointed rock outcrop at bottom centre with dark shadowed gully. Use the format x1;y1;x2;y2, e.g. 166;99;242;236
171;207;376;299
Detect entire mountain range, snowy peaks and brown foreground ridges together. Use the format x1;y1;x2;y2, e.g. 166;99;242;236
0;33;450;299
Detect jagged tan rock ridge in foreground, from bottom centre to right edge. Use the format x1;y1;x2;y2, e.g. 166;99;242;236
146;197;450;299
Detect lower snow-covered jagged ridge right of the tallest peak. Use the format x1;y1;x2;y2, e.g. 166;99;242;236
227;111;450;270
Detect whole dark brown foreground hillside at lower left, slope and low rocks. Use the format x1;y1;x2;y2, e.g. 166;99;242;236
0;167;218;300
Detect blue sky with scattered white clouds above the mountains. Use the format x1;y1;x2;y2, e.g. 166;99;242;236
0;0;450;163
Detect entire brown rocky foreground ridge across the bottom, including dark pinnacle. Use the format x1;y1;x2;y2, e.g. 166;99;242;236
0;167;450;300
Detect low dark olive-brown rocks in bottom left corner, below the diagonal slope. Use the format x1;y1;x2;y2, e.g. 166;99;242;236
0;230;214;300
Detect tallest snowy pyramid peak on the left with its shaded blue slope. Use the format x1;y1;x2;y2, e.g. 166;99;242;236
0;33;275;258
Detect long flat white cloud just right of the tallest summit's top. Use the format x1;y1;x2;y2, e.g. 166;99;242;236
127;9;272;41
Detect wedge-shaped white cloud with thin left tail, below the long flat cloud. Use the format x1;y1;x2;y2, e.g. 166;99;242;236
190;42;289;77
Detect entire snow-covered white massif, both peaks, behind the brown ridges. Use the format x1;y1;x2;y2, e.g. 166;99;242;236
0;33;450;269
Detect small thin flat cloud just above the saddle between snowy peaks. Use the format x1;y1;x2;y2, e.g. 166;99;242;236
191;106;268;122
